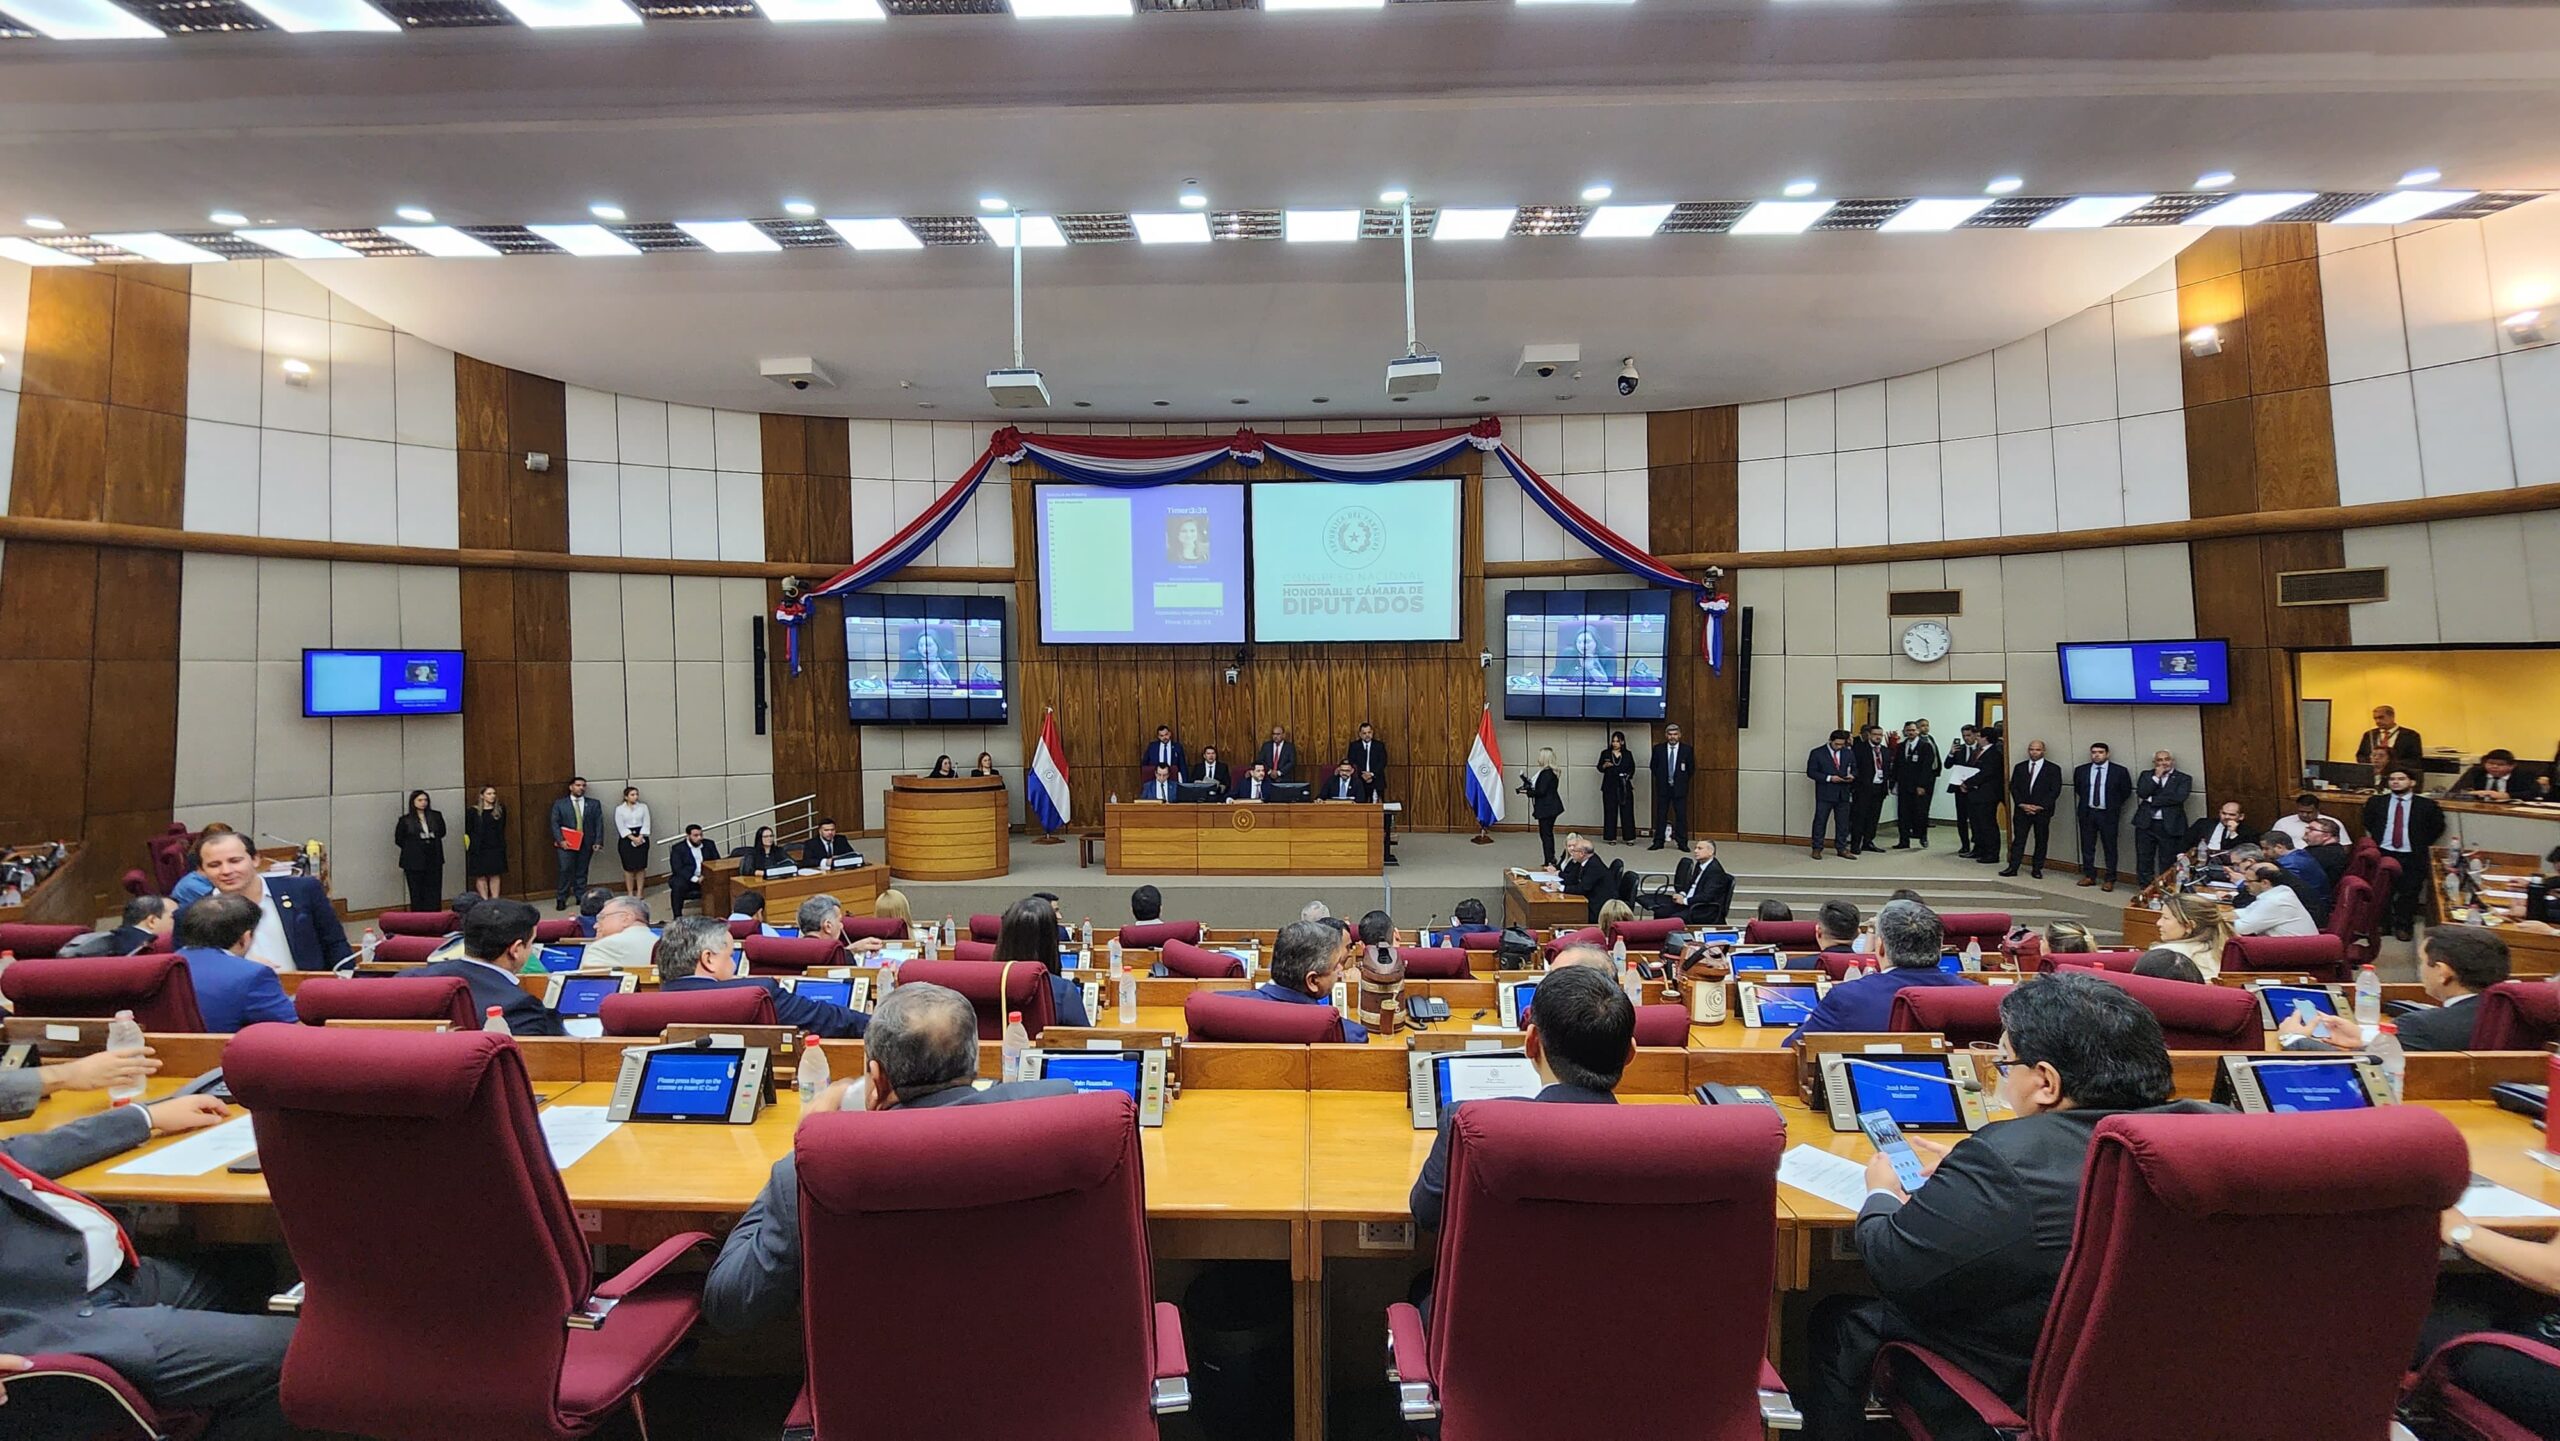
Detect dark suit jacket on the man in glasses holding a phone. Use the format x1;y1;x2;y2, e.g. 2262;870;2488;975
1856;1101;2217;1408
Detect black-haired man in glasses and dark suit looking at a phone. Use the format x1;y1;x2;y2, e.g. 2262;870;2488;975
1802;967;2217;1441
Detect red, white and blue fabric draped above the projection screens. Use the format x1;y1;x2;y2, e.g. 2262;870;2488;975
812;417;1720;604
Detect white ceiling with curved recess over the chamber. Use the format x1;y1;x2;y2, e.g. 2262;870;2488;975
0;0;2560;417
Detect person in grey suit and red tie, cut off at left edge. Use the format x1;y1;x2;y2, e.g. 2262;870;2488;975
0;1095;294;1441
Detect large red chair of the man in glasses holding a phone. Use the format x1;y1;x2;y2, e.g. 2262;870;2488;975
1876;1110;2470;1441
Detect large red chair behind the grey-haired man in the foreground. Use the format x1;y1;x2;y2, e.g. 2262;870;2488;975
794;1093;1190;1441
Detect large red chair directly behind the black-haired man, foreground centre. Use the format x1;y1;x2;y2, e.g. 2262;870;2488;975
1388;1101;1792;1441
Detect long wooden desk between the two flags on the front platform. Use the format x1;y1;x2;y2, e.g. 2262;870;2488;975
1103;801;1385;875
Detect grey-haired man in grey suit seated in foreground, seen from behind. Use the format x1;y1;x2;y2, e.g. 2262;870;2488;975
701;980;1075;1334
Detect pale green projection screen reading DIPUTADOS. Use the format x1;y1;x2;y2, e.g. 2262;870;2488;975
1252;479;1459;640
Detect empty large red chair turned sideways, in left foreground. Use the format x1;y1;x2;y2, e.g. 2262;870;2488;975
223;1026;709;1441
